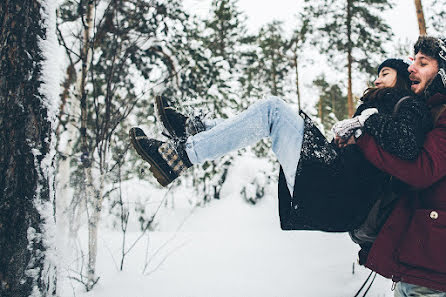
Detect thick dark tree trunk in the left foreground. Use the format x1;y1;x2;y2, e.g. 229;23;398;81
0;0;55;297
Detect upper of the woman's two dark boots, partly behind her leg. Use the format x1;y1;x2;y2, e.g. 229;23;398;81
155;95;206;139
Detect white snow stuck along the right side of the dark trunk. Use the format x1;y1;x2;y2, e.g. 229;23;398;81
33;0;63;297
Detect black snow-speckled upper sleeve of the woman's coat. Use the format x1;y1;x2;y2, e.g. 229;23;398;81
364;97;432;160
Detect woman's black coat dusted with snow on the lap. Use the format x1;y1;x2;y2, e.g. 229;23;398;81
279;90;432;232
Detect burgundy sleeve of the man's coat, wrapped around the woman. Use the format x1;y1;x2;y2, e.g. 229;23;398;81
357;112;446;188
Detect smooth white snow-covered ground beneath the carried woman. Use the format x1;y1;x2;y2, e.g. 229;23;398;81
59;158;392;297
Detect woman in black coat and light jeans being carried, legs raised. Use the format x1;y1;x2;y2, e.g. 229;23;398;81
130;59;432;231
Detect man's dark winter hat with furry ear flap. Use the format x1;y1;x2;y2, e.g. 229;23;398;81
414;36;446;98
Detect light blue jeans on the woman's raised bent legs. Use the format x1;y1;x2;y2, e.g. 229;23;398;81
186;97;304;194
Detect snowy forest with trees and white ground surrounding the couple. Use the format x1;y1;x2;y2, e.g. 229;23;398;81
0;0;446;296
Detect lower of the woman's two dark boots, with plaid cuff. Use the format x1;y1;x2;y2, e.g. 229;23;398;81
129;127;192;187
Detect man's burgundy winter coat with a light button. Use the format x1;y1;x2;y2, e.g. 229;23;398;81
357;94;446;292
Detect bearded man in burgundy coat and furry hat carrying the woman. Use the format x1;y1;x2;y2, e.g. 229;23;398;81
356;36;446;297
